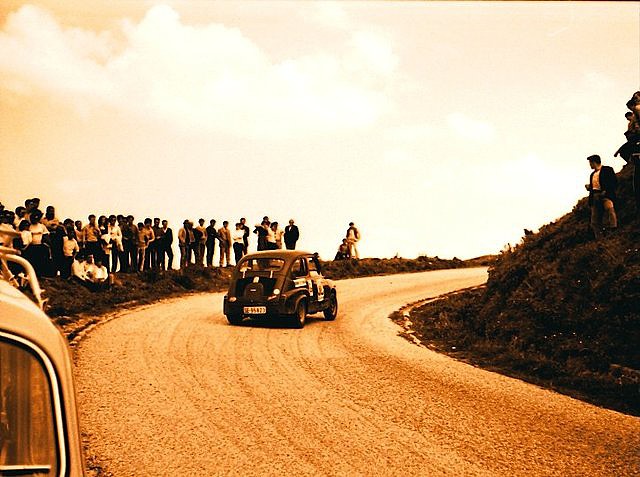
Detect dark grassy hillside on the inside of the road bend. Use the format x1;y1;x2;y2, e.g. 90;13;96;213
396;161;640;414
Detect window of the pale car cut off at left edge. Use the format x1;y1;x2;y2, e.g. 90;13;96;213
0;337;58;476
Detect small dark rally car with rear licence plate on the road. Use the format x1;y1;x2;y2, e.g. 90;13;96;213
224;250;338;328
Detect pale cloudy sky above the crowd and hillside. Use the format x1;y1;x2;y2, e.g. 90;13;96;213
0;0;640;260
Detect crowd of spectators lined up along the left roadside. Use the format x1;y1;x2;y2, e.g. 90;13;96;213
0;198;308;288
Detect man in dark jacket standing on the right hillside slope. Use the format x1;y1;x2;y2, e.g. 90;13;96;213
585;154;618;239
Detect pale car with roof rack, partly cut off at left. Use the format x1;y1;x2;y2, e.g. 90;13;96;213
0;240;84;477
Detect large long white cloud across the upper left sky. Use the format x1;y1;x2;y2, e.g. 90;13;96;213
0;6;396;139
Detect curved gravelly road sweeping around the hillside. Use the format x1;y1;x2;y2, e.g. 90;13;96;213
77;269;640;476
